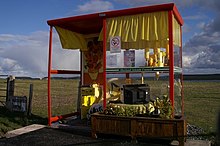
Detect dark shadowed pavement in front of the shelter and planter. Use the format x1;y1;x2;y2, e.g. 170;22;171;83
0;127;174;146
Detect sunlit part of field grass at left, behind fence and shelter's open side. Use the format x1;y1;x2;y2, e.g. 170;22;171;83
11;80;78;117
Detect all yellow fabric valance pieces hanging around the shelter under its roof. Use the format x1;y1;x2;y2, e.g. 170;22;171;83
55;11;181;51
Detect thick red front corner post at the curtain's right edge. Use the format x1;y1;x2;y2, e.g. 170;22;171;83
168;11;174;109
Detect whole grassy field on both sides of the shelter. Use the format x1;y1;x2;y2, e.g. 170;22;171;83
0;79;220;136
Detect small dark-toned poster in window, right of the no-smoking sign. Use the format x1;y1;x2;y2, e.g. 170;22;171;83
124;50;135;67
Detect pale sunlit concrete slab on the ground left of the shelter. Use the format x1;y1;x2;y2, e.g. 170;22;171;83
5;124;46;138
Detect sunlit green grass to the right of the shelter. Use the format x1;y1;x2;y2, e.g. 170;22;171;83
184;81;220;133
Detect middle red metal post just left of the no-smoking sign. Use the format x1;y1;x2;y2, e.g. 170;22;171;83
103;18;107;109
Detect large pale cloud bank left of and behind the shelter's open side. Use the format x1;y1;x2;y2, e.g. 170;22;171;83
0;31;79;77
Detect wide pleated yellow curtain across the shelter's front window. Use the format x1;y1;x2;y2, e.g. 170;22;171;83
99;11;168;49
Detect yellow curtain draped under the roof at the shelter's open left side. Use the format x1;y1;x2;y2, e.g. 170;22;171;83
55;26;87;51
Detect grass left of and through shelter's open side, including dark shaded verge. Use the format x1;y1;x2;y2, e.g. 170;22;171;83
0;79;78;137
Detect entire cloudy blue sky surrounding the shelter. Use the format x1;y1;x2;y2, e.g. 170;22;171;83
0;0;220;77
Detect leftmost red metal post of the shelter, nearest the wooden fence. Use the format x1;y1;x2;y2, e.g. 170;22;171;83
47;26;53;126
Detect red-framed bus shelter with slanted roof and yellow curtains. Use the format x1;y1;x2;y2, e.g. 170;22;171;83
47;3;185;144
